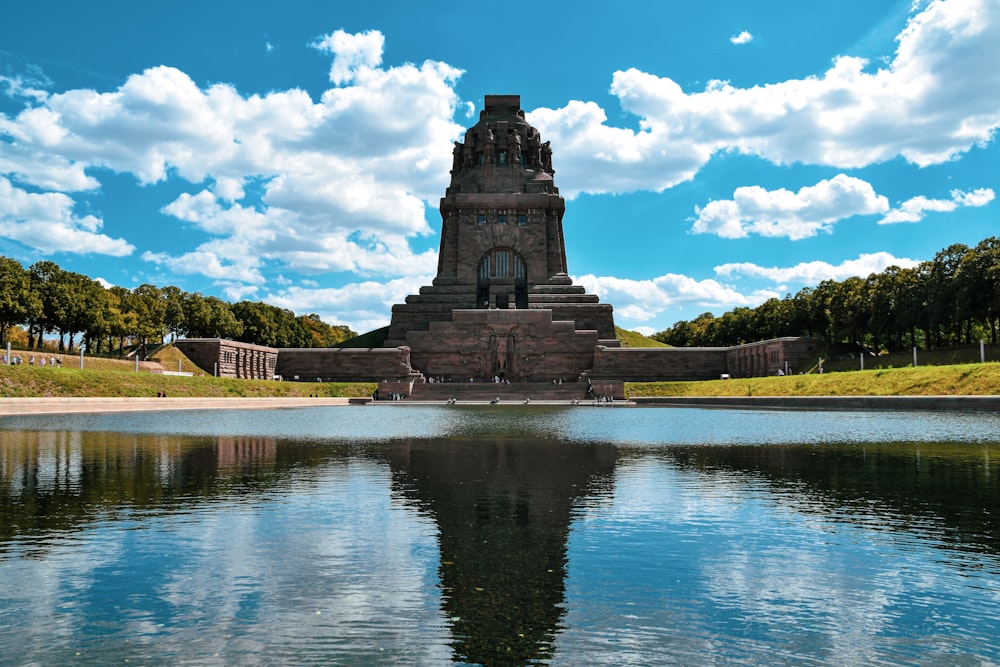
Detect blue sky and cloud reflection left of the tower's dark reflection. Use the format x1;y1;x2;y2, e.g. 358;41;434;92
0;459;451;665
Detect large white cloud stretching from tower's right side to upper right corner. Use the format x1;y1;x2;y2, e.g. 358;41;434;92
528;0;1000;196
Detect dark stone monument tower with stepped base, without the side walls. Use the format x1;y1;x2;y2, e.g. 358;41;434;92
385;95;618;382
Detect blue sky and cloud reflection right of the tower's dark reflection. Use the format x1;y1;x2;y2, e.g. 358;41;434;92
554;457;998;665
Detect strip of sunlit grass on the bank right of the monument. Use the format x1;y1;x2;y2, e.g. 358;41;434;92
625;362;1000;397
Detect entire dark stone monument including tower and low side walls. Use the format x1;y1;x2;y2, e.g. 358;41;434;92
179;95;820;399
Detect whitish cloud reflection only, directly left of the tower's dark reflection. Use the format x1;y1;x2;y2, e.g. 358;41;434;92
151;461;450;662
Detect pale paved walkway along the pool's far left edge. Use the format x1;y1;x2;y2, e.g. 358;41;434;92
0;398;367;415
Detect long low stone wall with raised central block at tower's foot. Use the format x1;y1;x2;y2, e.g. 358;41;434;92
175;336;823;383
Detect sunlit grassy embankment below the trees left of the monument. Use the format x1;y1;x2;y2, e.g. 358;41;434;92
0;346;376;398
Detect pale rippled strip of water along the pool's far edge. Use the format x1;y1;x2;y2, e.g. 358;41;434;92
11;405;1000;447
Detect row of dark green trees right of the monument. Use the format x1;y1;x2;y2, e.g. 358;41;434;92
653;237;1000;351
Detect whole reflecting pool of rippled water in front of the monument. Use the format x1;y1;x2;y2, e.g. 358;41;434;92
0;405;1000;665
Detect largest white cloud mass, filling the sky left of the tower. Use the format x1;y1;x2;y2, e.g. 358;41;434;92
0;31;462;289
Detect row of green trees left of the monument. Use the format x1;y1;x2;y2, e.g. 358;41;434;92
0;257;357;354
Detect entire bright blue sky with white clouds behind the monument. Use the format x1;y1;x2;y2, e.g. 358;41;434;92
0;0;1000;333
